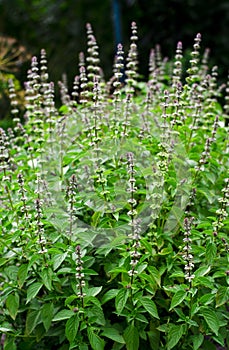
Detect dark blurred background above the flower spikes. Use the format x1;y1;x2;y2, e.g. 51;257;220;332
0;0;229;118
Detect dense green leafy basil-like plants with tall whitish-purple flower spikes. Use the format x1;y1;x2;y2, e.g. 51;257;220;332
0;23;229;350
